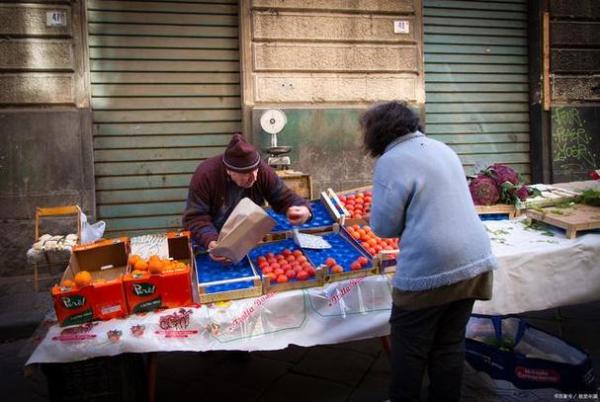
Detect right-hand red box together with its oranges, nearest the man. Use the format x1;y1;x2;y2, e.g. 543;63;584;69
123;232;195;314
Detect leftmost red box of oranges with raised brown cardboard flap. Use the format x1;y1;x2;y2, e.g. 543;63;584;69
51;237;129;325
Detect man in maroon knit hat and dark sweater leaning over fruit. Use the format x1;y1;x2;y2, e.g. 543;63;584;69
183;133;311;261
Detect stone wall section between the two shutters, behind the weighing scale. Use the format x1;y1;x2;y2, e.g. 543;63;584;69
241;0;424;194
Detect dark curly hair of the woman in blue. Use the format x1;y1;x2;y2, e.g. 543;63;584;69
360;101;423;158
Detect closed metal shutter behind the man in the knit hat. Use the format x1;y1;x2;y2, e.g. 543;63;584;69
87;0;241;236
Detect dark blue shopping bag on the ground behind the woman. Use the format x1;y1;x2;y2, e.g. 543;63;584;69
465;314;596;393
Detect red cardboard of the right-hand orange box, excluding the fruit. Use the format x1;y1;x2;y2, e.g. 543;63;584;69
123;232;195;314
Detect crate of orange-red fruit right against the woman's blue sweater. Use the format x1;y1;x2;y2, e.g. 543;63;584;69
345;224;399;273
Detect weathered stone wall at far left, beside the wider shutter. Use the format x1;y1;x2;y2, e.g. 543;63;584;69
0;1;94;276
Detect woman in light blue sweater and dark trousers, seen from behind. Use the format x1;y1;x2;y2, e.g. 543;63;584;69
361;102;497;402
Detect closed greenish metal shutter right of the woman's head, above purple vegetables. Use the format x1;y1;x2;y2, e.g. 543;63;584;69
424;0;530;180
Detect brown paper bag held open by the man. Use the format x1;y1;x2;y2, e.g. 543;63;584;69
212;198;276;264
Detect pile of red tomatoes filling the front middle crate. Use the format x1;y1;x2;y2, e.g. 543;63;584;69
256;248;315;283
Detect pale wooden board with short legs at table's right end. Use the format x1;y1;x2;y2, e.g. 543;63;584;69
527;204;600;239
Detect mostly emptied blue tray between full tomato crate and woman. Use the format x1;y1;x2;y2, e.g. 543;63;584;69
304;232;373;272
